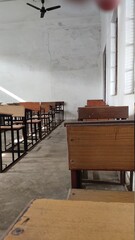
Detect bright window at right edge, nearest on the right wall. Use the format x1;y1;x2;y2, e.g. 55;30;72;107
124;0;135;94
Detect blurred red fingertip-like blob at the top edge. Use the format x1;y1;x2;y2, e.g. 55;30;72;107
95;0;120;11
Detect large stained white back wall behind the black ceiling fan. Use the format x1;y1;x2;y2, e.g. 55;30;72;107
0;0;102;119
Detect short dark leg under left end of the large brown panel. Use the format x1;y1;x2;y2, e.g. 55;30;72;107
71;170;81;188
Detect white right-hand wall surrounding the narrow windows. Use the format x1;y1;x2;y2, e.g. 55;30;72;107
101;0;134;119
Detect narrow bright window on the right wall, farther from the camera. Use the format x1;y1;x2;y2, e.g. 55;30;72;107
110;12;118;96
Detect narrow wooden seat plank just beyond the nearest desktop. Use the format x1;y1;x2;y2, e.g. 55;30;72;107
68;189;135;203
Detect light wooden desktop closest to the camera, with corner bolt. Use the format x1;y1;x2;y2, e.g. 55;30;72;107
4;199;134;240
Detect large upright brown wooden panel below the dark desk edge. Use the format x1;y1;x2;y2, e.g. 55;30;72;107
67;124;135;171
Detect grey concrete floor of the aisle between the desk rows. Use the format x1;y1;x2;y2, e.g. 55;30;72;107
0;124;126;238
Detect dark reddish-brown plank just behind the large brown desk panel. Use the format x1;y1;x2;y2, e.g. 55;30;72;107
78;106;128;121
